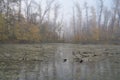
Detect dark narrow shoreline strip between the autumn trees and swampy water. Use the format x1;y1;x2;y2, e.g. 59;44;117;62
0;40;120;45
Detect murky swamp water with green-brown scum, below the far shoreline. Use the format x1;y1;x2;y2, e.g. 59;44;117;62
0;43;120;80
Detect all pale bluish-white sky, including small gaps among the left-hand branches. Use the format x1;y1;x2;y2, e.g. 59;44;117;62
23;0;111;21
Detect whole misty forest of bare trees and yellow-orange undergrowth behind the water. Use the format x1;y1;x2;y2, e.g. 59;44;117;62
0;0;120;43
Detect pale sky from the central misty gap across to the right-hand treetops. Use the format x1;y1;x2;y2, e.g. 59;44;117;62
56;0;111;19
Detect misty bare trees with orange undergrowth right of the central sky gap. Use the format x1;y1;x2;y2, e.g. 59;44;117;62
67;0;120;43
